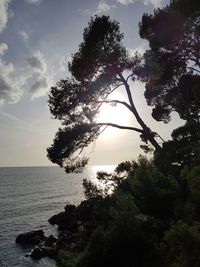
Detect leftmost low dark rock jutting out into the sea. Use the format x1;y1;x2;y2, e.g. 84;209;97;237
16;230;45;245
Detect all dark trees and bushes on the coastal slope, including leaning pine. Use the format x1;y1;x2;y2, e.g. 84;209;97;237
48;0;200;267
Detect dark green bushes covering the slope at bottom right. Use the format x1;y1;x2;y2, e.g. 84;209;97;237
56;157;200;267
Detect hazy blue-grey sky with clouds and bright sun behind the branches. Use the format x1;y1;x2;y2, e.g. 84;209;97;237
0;0;181;166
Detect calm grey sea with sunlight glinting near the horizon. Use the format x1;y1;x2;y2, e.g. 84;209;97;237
0;165;115;267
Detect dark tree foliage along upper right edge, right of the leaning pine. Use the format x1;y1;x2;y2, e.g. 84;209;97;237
139;0;200;180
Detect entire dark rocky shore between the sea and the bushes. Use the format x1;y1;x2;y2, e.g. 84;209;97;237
16;198;101;259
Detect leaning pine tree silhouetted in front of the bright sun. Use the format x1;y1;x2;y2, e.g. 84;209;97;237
47;16;161;172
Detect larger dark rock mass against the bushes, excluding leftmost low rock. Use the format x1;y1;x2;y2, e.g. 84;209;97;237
44;198;102;258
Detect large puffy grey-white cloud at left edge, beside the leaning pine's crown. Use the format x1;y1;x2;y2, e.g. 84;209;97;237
0;47;52;104
